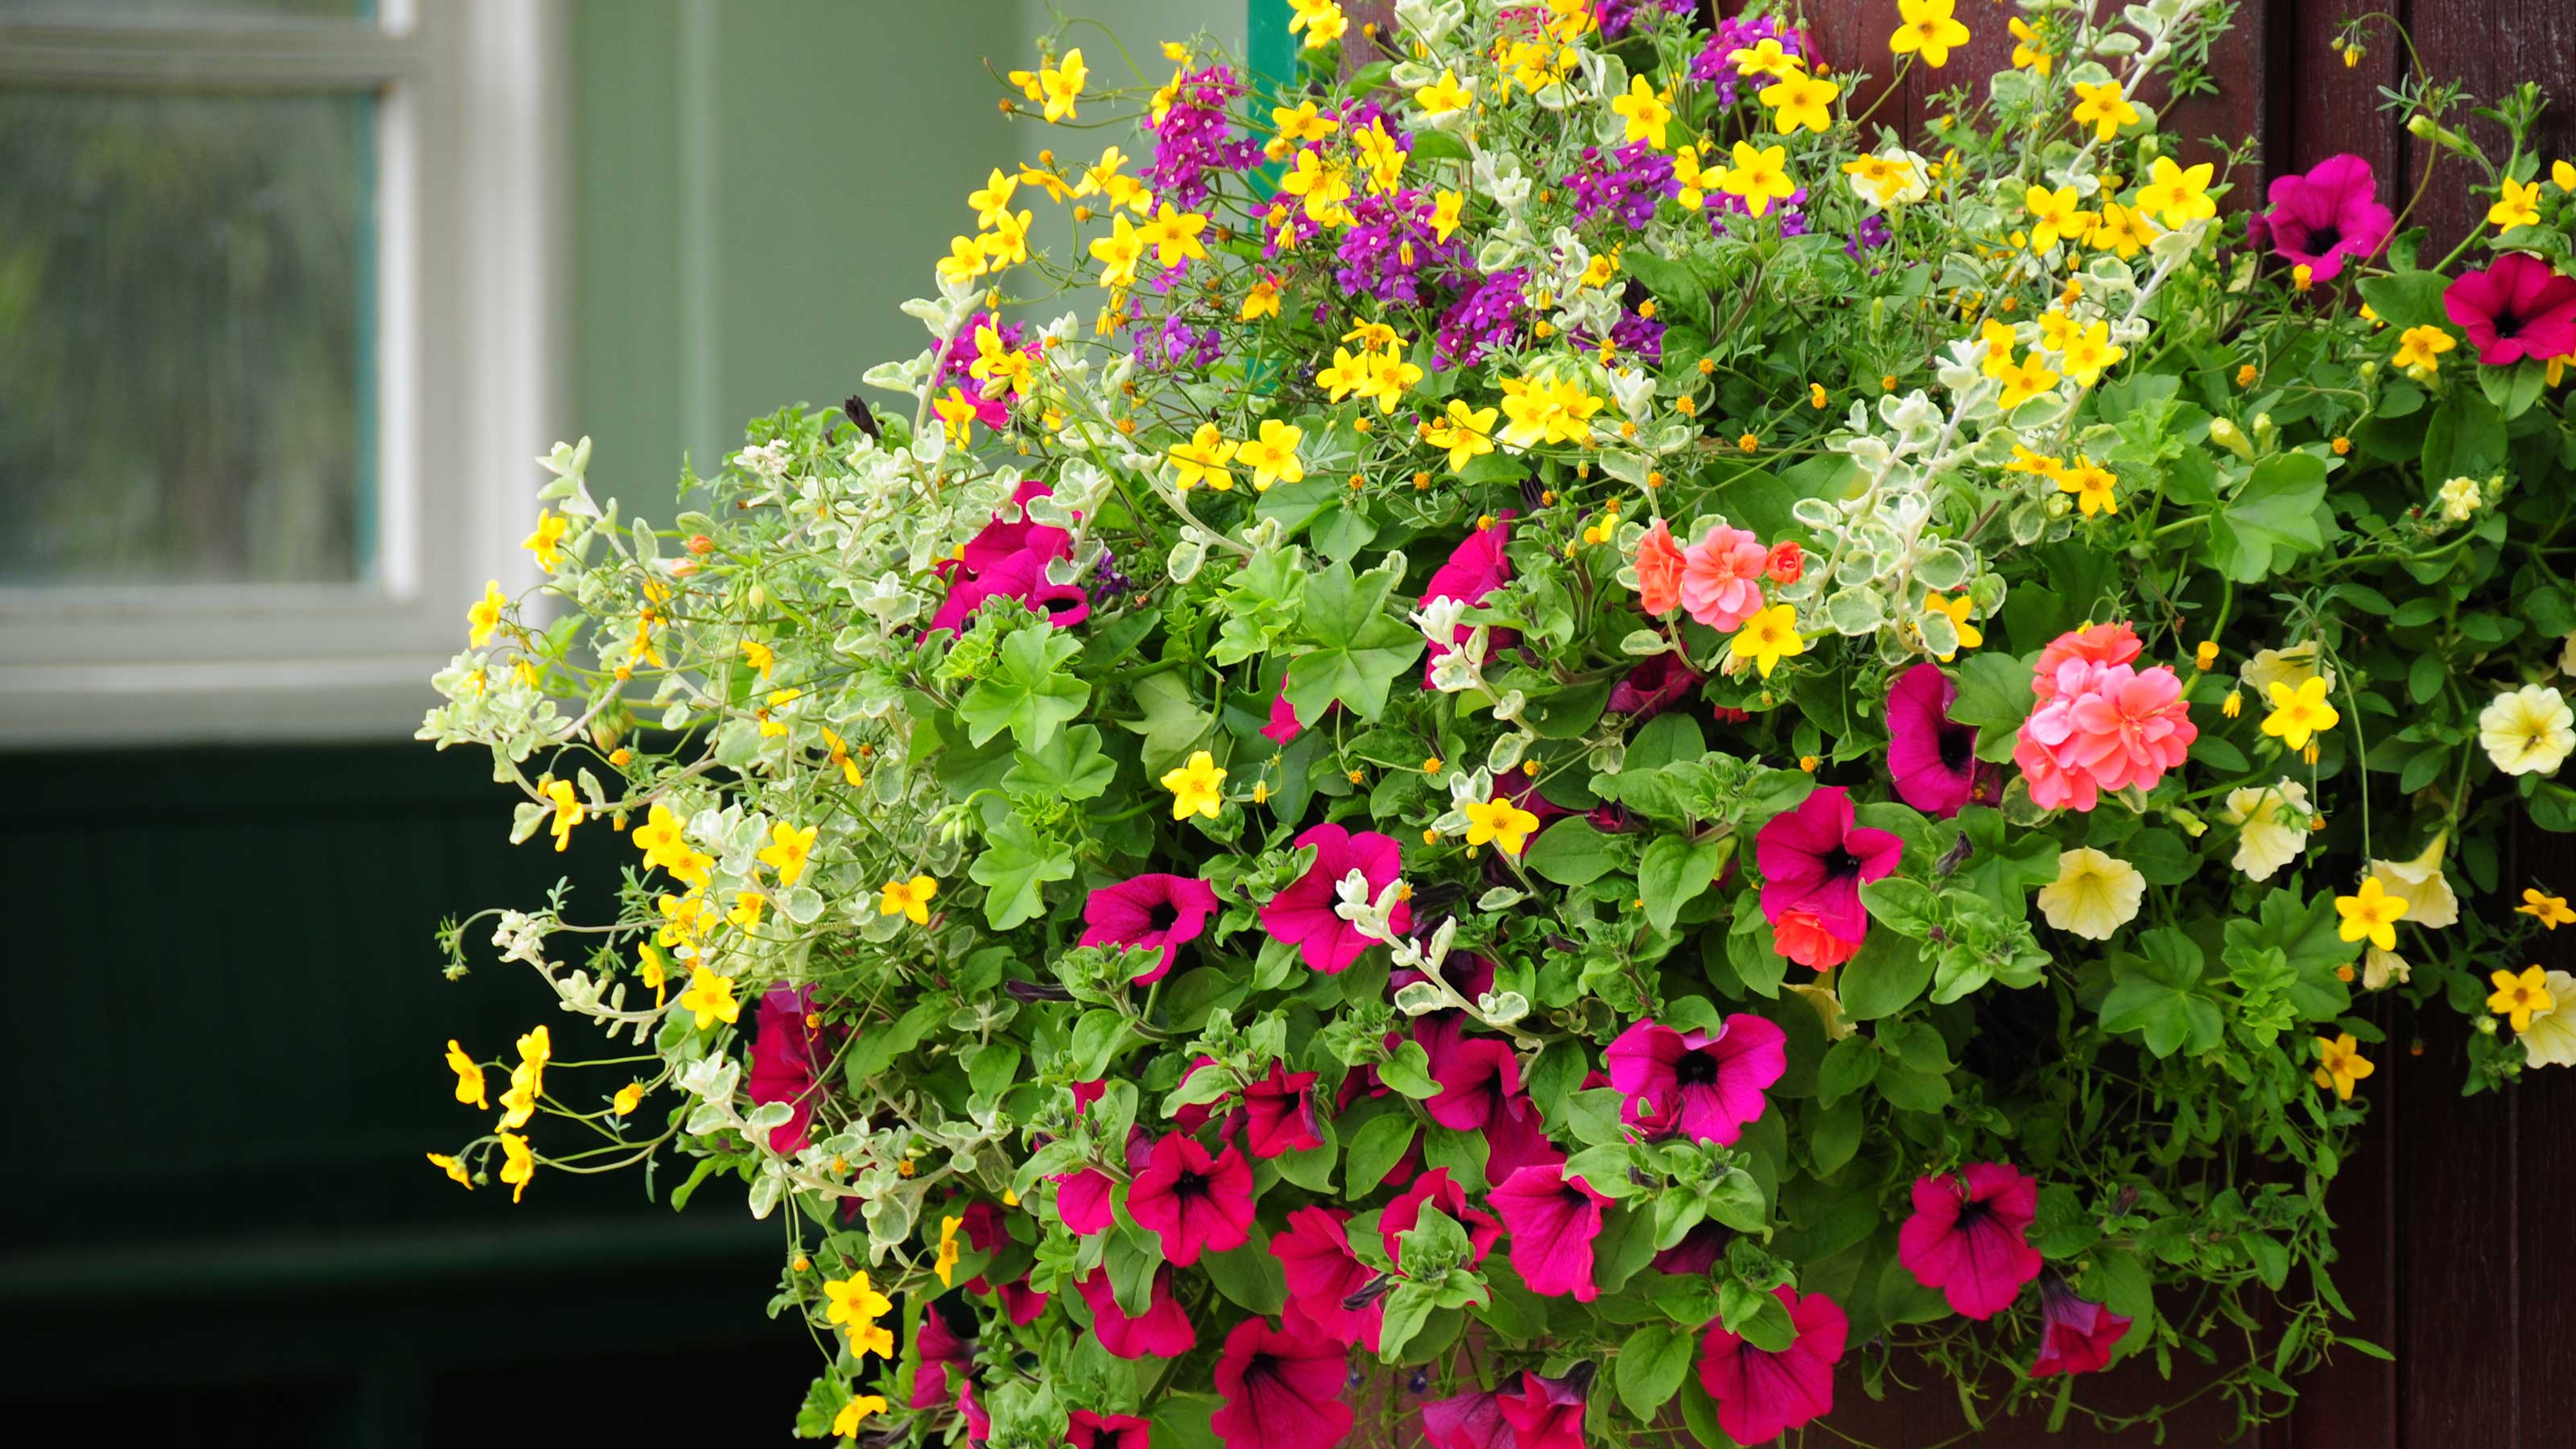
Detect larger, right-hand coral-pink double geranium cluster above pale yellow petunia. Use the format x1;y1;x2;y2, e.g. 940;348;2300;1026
2012;658;2200;810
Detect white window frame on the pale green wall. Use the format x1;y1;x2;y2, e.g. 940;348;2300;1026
0;0;569;748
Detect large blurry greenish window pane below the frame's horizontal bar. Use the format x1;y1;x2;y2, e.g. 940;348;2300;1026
0;90;376;585
